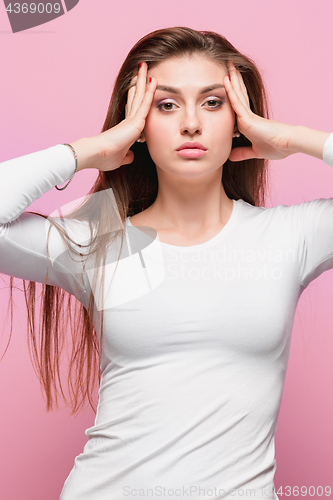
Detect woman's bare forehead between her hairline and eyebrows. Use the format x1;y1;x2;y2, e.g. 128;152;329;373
148;54;228;87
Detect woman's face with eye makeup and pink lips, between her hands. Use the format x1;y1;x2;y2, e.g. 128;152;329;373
142;55;235;177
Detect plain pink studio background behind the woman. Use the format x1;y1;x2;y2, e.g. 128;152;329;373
0;0;333;500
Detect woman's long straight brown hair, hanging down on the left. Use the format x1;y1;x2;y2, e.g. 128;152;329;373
0;27;268;414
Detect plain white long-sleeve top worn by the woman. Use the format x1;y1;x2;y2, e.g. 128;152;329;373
0;134;333;500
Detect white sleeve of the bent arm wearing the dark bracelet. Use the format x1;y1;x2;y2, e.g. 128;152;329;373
0;144;86;300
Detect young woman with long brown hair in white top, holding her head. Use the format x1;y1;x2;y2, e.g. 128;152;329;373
0;27;333;500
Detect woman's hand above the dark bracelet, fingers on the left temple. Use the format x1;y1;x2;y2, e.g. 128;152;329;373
71;62;157;171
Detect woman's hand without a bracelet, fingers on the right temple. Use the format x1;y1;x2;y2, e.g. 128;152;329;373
224;62;296;161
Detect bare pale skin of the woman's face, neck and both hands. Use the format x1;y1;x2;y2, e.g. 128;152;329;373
71;54;330;246
